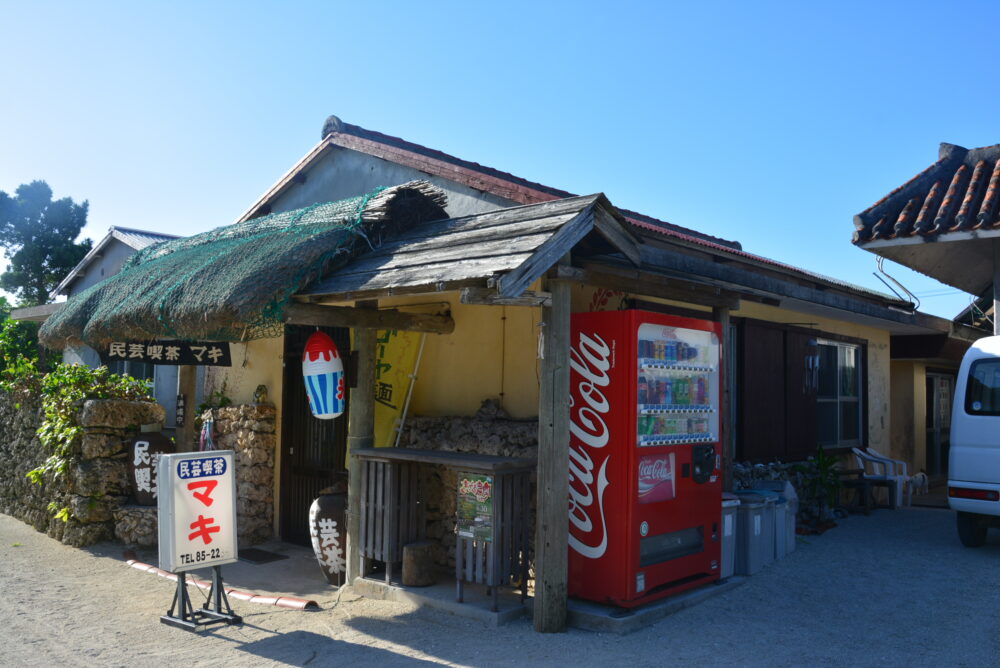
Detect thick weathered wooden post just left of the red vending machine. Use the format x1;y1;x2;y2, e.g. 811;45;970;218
534;281;570;633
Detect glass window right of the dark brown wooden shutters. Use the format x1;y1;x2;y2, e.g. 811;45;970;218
816;340;862;447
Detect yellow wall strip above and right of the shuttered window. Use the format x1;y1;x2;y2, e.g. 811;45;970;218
731;301;892;452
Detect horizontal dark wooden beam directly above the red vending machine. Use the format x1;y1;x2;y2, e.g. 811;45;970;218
556;262;741;309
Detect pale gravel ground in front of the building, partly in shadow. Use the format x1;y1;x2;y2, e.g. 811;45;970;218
0;508;1000;666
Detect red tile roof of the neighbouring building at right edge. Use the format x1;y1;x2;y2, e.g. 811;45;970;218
854;144;1000;245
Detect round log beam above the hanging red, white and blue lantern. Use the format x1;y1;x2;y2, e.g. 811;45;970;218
285;303;455;334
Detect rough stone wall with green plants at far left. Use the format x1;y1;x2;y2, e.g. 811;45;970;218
0;393;163;546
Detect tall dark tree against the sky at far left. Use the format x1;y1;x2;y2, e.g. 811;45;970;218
0;181;92;306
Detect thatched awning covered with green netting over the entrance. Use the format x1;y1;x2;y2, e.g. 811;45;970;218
39;181;446;348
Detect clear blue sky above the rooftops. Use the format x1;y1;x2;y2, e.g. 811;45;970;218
0;0;1000;317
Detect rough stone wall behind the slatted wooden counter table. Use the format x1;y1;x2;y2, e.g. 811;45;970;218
400;400;538;571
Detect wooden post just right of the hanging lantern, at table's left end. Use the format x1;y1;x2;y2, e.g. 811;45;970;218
347;301;378;584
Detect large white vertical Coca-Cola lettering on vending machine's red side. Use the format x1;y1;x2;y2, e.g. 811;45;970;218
569;332;611;559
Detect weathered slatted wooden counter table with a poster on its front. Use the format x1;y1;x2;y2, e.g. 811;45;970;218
352;448;535;611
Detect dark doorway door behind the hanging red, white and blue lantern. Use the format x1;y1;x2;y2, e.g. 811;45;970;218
279;326;351;545
